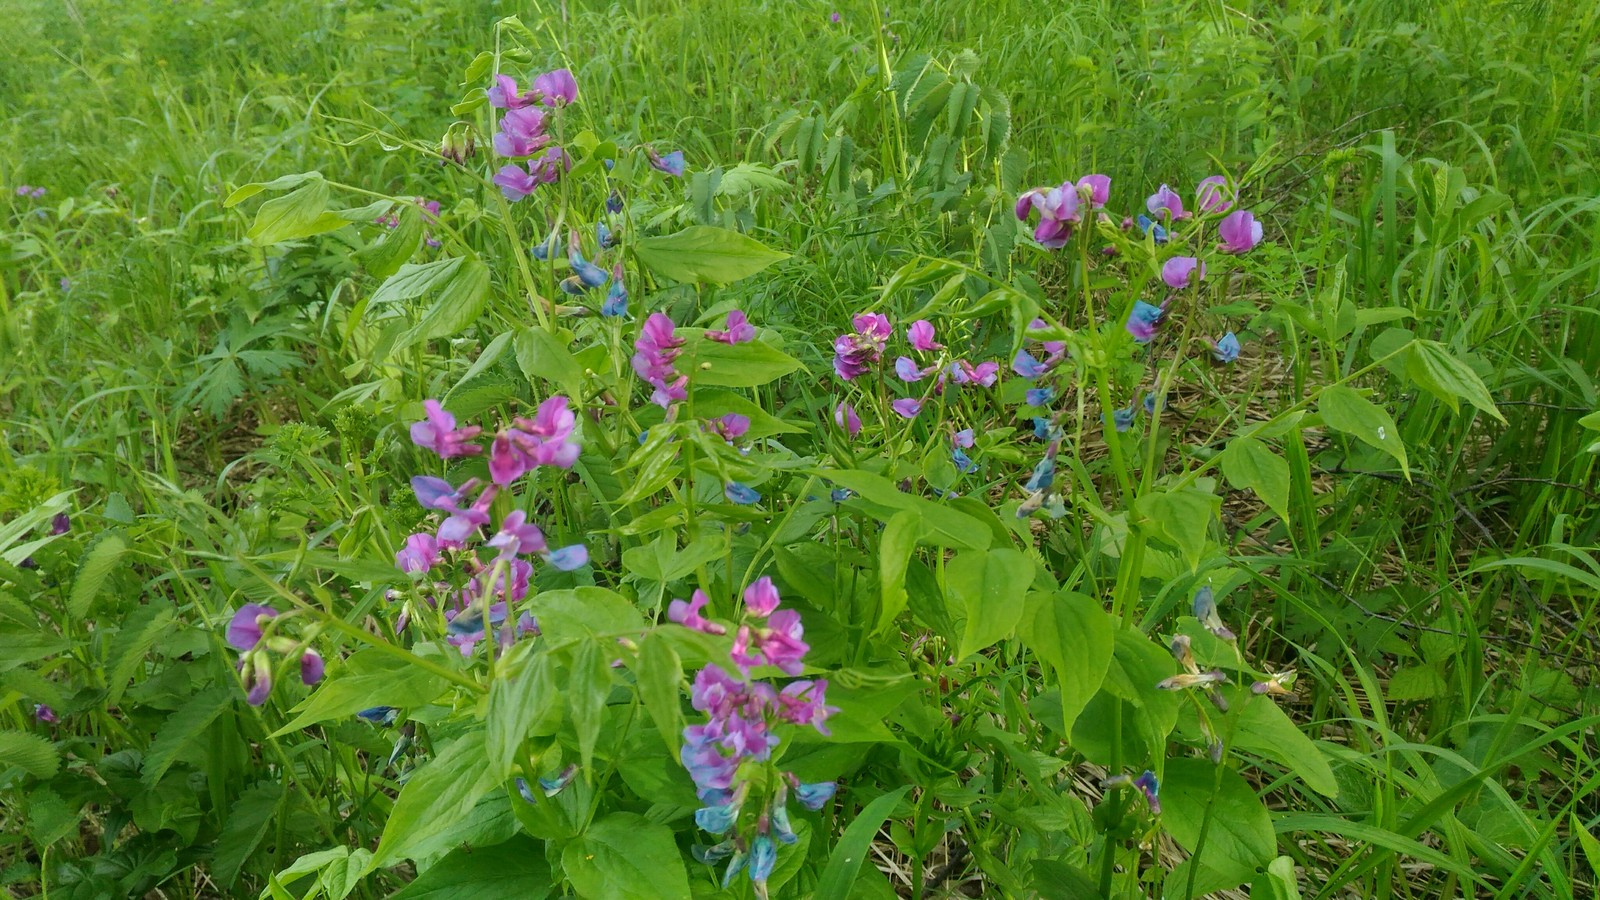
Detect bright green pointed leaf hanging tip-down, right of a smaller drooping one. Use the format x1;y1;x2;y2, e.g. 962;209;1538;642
1018;591;1117;735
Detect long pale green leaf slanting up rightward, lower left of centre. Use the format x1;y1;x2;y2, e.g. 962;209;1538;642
373;730;499;868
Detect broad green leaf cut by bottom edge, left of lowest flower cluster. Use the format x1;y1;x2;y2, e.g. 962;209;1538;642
562;812;690;900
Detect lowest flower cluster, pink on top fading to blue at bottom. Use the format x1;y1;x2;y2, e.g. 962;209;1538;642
667;578;837;898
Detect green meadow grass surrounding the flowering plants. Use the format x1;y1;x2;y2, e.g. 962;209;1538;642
0;0;1600;898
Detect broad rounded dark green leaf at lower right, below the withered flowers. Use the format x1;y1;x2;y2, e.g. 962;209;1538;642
1160;759;1277;894
